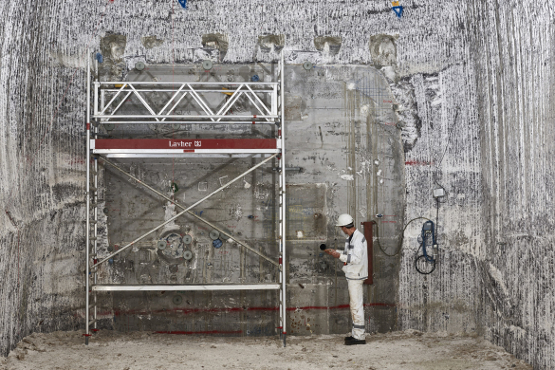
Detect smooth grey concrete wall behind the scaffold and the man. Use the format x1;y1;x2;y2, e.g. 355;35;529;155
94;63;405;335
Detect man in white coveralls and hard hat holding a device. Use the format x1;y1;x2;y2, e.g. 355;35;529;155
324;214;368;345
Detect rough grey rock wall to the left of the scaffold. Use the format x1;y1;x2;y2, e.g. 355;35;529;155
0;1;85;354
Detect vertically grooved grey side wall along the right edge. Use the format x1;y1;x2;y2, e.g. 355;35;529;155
469;1;555;369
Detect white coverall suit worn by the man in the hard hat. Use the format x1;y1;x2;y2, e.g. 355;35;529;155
339;230;368;340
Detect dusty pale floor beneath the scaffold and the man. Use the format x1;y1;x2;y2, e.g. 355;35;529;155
0;331;532;370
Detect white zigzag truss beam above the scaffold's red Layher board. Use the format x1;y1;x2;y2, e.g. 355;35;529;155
92;81;280;124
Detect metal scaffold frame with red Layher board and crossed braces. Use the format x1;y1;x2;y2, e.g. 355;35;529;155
84;52;287;346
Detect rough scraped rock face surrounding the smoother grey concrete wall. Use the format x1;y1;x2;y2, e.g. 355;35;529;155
0;0;555;369
